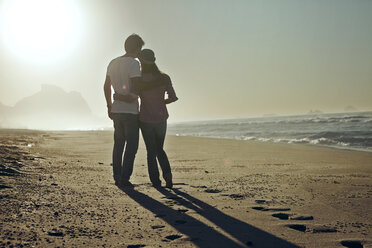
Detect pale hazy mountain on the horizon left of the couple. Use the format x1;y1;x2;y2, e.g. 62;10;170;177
0;85;107;130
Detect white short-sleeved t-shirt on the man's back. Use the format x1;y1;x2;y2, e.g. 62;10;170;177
107;56;141;114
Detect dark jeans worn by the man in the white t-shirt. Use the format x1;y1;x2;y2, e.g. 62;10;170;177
112;113;139;181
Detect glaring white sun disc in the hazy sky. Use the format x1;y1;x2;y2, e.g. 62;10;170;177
0;0;83;64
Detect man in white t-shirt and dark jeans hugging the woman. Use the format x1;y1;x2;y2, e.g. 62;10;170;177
104;34;166;187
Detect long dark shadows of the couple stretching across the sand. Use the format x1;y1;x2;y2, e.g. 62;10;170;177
122;188;299;248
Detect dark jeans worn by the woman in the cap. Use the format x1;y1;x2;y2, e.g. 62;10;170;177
140;121;172;185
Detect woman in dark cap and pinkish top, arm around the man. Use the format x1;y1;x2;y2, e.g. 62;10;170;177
116;49;178;188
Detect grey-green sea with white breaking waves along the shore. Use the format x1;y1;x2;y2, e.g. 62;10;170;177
168;112;372;152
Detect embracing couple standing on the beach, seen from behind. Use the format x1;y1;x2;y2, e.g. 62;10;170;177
104;34;178;188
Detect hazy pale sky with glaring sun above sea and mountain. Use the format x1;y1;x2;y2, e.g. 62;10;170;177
0;0;372;121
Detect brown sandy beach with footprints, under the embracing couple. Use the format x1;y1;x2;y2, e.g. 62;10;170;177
0;130;372;248
